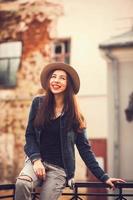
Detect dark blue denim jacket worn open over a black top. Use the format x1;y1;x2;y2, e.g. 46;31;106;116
24;97;109;182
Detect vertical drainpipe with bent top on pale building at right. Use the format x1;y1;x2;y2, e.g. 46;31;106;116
105;50;120;177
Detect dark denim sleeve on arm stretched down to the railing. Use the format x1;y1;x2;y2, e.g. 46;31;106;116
76;130;109;182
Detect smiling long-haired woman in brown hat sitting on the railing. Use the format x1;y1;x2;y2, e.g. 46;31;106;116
15;63;124;200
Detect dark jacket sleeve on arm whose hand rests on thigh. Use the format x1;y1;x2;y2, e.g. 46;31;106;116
24;97;41;161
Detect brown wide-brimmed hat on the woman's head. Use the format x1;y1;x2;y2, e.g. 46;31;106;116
40;62;80;94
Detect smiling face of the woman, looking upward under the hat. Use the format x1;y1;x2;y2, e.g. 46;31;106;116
49;70;67;94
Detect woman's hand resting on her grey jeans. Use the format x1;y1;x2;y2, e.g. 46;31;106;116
33;159;46;179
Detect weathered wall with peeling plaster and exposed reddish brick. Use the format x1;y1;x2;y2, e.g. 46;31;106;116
0;0;62;183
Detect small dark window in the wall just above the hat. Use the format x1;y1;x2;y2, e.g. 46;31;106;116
52;38;70;64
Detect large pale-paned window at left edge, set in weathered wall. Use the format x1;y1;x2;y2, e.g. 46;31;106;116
0;42;22;88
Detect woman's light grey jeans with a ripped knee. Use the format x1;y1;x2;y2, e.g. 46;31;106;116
15;159;66;200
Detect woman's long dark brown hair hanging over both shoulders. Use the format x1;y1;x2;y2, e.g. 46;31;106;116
34;72;86;132
